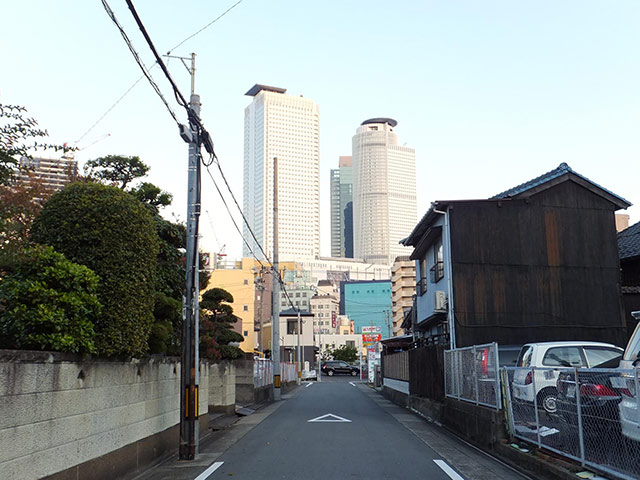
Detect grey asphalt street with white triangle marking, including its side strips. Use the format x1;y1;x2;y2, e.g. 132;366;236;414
135;376;531;480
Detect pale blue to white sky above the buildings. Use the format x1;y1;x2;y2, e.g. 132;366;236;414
0;0;640;259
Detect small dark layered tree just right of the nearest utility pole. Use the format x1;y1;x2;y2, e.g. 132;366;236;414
200;288;244;360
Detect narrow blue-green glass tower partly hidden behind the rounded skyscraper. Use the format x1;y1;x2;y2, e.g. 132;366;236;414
331;157;353;258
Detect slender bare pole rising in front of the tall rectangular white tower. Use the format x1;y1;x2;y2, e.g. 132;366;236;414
271;157;280;401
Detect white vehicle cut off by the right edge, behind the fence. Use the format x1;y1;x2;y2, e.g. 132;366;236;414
619;311;640;441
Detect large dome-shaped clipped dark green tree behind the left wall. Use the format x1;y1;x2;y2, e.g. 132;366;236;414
31;183;158;357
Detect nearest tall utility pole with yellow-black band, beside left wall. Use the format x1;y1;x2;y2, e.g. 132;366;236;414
179;53;201;460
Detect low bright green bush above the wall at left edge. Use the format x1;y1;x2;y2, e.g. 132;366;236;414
0;247;101;353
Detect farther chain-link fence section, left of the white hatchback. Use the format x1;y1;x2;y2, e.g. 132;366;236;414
444;343;502;409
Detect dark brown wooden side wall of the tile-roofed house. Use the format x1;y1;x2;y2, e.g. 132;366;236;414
451;182;626;346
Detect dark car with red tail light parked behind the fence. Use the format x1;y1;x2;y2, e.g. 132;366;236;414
556;348;622;436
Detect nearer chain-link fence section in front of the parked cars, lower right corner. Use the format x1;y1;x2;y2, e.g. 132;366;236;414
503;367;640;479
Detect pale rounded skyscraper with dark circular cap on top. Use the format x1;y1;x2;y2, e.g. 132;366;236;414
352;118;417;265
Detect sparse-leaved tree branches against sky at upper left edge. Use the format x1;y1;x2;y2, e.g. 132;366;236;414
0;104;76;185
